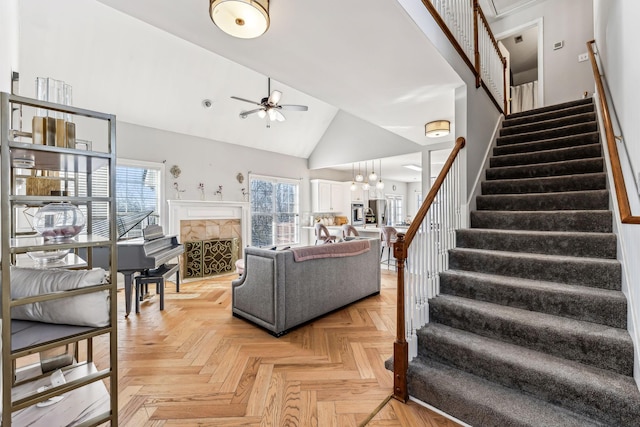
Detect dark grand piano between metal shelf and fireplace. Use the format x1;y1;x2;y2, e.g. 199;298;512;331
93;214;184;317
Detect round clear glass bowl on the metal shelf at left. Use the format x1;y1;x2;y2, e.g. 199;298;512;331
33;202;85;240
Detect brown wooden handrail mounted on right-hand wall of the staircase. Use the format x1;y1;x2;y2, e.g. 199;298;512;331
587;40;640;224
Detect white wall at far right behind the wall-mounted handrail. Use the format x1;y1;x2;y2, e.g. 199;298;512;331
593;0;640;390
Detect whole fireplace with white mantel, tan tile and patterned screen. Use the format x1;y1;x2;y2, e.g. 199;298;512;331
168;200;250;278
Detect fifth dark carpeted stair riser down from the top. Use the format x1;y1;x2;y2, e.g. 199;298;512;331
489;144;602;168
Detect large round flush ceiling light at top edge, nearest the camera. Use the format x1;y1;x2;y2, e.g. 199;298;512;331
209;0;269;39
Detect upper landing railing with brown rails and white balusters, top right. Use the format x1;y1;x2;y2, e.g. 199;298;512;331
422;0;508;113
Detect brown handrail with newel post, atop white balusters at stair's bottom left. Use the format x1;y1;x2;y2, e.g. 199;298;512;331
393;137;466;402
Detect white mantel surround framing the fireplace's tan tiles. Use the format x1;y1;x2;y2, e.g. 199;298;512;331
167;200;251;245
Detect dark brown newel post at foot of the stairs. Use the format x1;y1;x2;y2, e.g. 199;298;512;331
393;233;409;402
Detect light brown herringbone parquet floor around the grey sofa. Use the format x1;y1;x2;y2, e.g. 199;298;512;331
96;270;456;427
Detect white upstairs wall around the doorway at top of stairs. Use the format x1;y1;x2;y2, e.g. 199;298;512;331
490;0;594;105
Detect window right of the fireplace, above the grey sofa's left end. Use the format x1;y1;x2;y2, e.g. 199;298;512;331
249;175;300;246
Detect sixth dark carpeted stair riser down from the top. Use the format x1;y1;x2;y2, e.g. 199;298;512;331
486;158;604;180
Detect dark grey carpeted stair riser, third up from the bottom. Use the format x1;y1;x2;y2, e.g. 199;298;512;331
429;297;633;376
